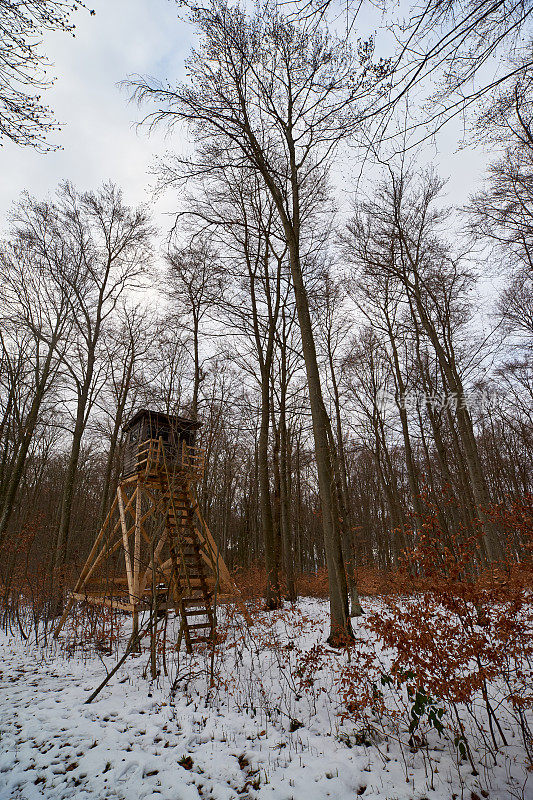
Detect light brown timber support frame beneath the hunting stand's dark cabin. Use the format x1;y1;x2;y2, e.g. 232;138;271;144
55;456;240;650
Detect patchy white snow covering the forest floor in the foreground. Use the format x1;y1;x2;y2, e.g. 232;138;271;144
0;600;533;800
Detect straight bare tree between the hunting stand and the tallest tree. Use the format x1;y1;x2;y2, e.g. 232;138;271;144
175;168;287;609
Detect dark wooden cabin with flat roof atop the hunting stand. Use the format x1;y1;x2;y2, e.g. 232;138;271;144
122;408;202;478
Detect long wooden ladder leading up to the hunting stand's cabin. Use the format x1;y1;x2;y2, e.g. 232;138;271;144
160;450;215;653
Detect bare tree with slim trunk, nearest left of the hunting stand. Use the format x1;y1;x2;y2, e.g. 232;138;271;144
46;184;152;608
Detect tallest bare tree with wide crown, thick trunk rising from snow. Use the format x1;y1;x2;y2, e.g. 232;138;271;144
130;0;387;642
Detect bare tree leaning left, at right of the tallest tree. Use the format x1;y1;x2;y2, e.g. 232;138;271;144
344;170;500;560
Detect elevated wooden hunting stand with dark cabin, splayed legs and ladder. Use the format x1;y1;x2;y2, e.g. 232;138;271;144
54;409;238;652
